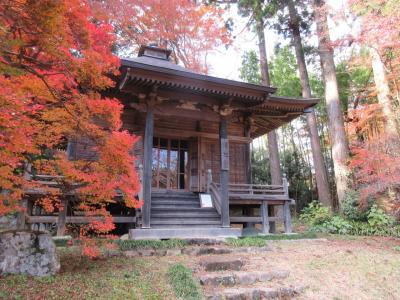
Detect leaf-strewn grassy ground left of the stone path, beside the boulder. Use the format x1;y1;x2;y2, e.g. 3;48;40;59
0;247;176;300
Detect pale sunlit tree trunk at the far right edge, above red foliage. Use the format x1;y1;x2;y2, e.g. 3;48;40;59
370;48;398;137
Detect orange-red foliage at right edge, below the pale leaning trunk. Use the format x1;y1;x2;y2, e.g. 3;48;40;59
348;104;400;214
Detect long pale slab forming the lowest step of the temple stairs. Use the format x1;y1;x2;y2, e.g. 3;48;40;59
129;225;242;240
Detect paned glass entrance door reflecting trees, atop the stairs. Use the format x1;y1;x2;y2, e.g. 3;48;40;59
152;138;188;189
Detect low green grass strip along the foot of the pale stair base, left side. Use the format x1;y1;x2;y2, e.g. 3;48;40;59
116;239;187;251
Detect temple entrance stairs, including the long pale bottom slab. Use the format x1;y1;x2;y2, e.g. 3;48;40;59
129;190;241;239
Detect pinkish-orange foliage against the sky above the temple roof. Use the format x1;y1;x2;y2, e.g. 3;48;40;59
92;0;231;73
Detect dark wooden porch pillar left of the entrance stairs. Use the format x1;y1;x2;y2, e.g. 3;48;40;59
142;105;154;228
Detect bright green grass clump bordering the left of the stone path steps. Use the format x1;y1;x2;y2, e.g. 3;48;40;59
168;264;202;300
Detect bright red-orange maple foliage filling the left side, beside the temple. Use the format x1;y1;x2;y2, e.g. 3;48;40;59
0;0;141;257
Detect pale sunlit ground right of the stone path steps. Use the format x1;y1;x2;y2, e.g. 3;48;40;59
188;237;400;300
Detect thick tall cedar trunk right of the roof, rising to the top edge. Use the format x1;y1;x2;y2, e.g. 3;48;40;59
313;0;349;205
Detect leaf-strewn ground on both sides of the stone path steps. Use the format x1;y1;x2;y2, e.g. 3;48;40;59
0;236;400;300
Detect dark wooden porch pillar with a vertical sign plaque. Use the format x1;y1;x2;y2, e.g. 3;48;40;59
219;115;230;227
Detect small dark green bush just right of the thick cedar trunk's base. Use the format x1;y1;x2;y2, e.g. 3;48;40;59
341;190;372;221
